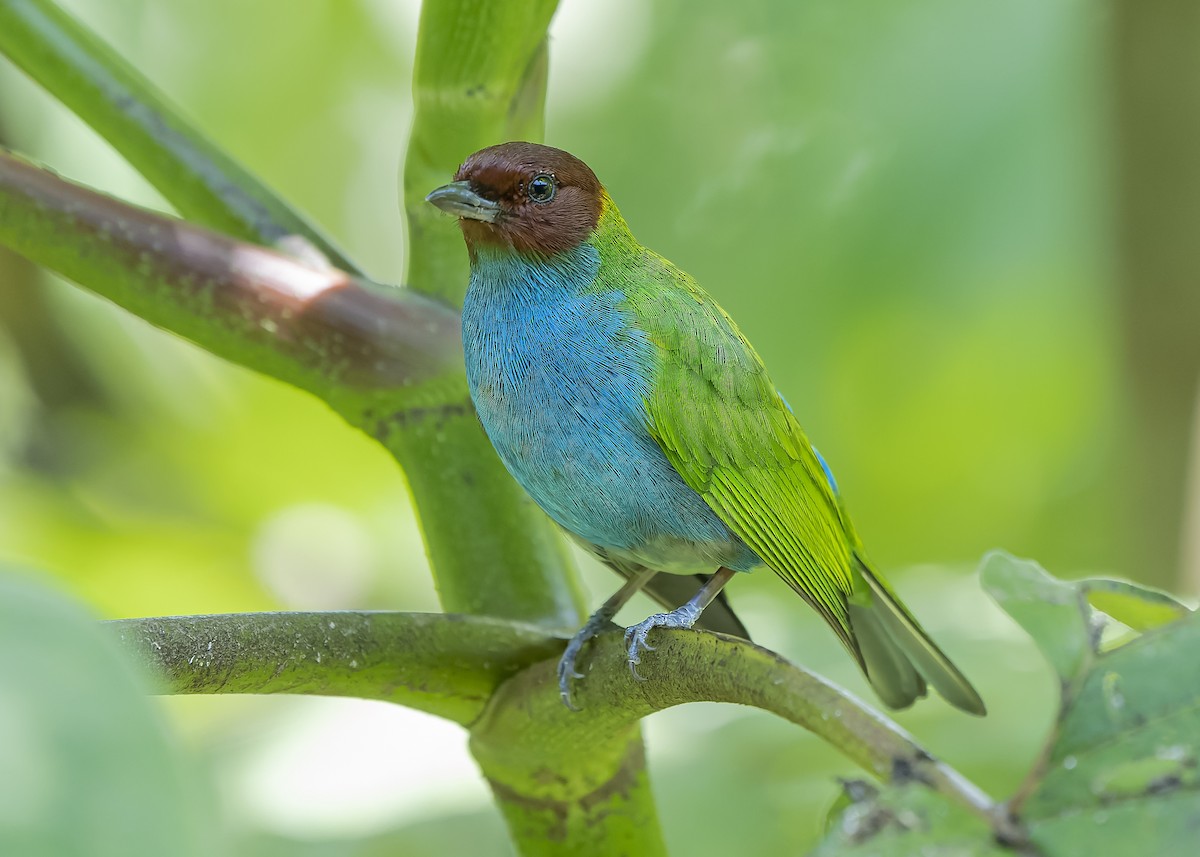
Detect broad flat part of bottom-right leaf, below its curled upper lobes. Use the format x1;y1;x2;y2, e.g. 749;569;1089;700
1021;613;1200;855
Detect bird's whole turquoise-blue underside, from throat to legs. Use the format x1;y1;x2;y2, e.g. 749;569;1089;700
462;245;758;570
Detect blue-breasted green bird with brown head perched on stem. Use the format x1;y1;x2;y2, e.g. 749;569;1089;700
426;142;986;715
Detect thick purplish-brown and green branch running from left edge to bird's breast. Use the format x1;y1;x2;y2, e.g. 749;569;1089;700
0;152;462;403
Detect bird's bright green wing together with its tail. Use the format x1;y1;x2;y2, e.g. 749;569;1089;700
624;244;986;714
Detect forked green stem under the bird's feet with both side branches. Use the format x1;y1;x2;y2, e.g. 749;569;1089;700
108;612;1003;855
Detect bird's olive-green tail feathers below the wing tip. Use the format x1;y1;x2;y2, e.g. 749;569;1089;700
848;555;988;717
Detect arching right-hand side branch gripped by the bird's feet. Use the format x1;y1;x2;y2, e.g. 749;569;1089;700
473;631;996;822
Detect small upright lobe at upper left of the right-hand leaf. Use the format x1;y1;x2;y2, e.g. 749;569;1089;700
979;551;1093;682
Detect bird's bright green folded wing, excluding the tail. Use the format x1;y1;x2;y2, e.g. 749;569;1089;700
626;251;865;669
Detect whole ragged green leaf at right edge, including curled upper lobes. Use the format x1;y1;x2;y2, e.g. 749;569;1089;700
983;553;1200;855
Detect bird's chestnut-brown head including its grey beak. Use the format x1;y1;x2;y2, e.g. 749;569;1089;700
426;143;604;256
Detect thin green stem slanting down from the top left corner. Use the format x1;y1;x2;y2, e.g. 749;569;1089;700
0;0;361;270
